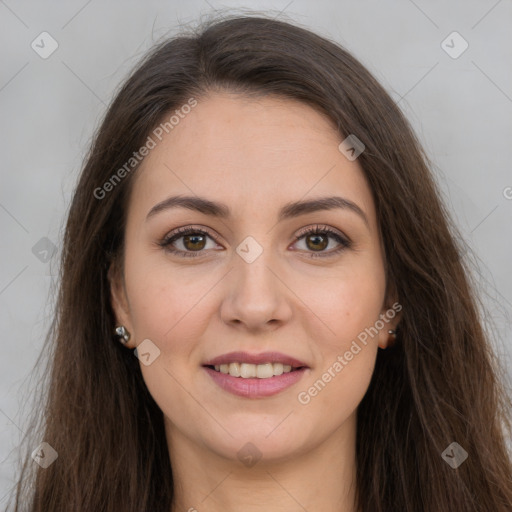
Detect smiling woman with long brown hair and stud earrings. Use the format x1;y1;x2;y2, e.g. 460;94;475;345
9;17;512;512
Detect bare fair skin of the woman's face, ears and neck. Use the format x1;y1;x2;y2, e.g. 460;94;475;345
111;93;400;512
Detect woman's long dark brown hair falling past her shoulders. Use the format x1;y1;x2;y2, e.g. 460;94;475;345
8;16;512;512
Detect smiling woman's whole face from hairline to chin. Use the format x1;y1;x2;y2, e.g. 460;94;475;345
112;93;398;460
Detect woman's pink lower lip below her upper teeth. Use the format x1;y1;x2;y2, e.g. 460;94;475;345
203;366;309;398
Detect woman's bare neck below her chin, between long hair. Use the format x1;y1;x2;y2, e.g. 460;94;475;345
166;413;357;512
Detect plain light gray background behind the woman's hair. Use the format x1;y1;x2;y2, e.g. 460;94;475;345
0;0;512;509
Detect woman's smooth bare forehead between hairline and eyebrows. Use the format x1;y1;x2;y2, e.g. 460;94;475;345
130;93;374;228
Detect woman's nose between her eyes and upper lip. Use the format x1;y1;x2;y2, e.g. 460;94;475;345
220;250;293;332
